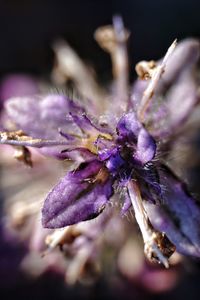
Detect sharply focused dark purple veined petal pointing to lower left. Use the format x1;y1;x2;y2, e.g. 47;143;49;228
42;160;113;228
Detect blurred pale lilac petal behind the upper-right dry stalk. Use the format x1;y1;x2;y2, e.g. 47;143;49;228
129;39;200;138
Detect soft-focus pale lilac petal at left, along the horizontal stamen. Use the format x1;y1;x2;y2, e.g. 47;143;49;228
1;95;84;159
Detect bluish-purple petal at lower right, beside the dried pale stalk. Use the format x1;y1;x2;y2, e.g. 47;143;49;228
144;166;200;256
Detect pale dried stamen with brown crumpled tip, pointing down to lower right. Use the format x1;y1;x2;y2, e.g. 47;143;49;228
128;180;169;268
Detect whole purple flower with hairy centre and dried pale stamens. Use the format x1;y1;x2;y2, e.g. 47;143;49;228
0;18;200;267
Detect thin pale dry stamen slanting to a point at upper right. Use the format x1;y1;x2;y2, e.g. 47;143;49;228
137;40;177;122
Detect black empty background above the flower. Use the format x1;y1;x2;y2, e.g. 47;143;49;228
0;0;200;80
